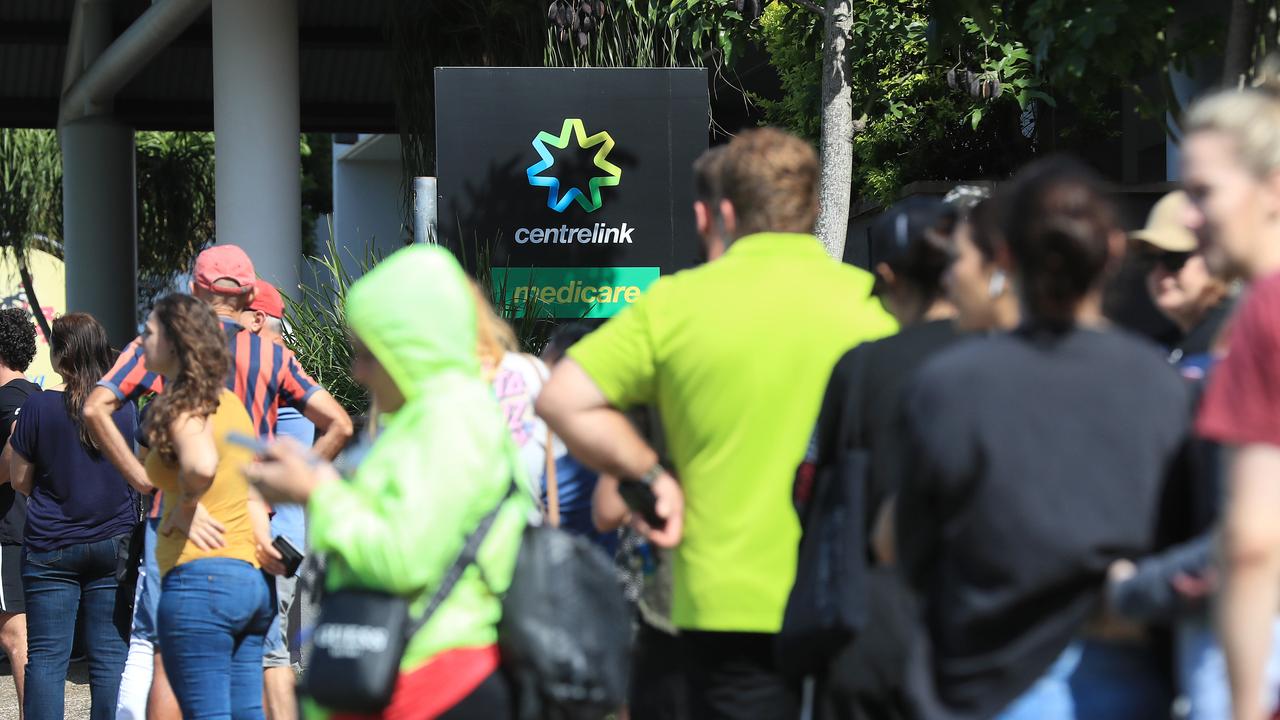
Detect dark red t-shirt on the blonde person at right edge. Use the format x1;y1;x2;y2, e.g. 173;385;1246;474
1196;273;1280;446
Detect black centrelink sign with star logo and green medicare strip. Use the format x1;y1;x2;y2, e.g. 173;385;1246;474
435;68;709;318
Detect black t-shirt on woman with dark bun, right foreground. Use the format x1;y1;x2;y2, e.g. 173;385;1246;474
896;329;1192;719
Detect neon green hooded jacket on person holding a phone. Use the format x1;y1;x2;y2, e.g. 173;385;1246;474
307;245;532;673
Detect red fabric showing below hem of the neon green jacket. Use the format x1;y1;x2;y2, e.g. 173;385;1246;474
332;646;499;720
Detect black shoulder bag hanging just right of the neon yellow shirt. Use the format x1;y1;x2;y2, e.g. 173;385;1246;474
776;345;870;678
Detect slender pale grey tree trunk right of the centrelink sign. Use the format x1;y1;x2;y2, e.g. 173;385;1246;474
815;0;854;260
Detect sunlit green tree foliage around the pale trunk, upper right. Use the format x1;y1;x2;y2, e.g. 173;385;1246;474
755;0;1221;202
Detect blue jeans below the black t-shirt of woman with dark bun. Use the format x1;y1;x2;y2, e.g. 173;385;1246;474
996;639;1172;720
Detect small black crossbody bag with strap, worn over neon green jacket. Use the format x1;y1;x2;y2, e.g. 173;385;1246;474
302;484;515;715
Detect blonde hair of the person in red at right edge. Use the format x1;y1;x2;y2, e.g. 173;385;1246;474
1183;87;1280;177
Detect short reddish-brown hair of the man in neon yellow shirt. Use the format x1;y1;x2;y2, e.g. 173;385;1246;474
718;128;818;236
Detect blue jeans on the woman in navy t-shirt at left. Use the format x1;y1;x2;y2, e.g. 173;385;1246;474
22;536;129;720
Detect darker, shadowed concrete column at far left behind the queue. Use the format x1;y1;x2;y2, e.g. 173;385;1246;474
60;117;138;347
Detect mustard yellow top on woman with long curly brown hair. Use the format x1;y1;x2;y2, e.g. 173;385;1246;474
146;389;259;575
